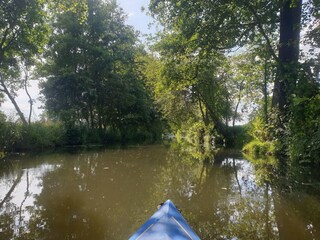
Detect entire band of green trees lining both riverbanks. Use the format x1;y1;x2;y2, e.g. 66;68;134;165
0;0;320;182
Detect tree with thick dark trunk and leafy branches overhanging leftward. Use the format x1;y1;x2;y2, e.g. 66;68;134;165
150;0;302;109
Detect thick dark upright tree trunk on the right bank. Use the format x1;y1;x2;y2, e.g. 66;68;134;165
272;0;302;114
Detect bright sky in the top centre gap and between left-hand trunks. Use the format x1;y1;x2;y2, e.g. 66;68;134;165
0;0;155;120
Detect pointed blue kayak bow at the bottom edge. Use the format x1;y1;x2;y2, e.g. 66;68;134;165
129;200;200;240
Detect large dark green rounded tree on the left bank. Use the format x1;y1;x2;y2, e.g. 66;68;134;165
42;0;158;142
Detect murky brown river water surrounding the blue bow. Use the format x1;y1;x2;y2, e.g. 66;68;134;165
0;146;320;240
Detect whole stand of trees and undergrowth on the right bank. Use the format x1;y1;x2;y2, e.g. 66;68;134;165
150;0;320;174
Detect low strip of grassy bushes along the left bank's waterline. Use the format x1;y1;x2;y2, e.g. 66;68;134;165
0;116;161;155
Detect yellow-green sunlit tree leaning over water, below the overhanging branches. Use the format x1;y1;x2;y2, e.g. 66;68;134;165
146;33;235;140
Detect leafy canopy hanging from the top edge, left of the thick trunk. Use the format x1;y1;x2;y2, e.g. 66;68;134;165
150;0;281;50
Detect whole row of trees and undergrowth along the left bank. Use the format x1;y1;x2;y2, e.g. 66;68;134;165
0;0;162;148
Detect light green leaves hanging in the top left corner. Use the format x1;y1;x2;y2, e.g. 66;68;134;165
0;0;48;62
